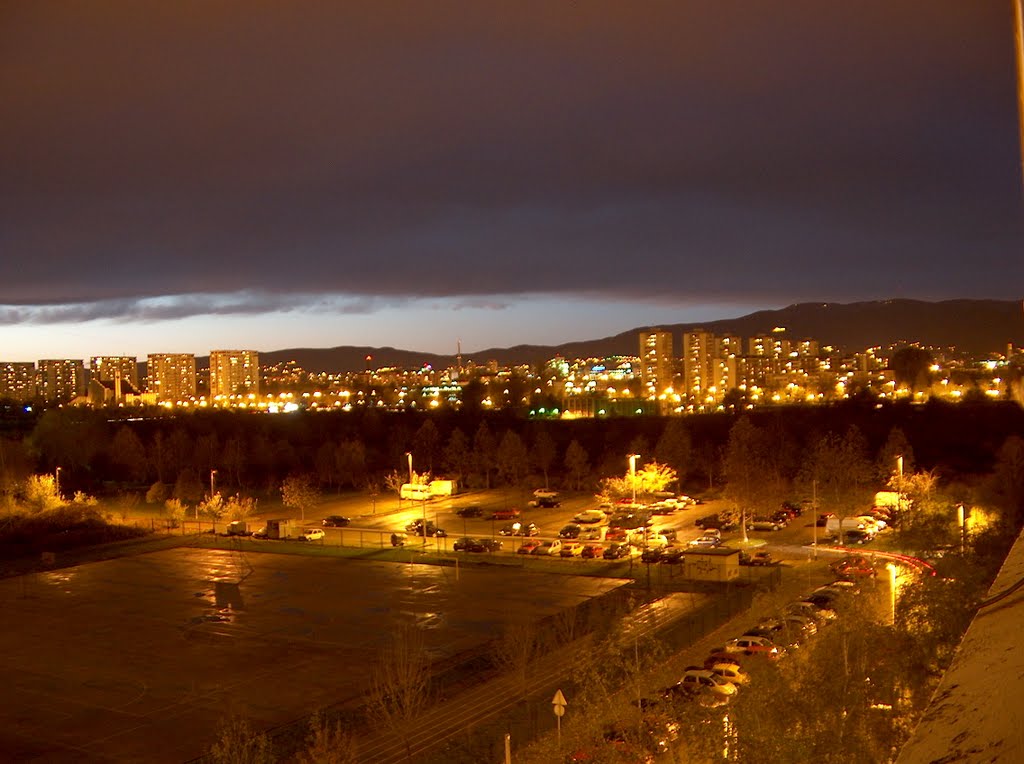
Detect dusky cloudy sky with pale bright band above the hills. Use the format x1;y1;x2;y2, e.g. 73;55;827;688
0;0;1024;360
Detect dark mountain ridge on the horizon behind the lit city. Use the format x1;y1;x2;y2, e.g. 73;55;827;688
249;300;1024;374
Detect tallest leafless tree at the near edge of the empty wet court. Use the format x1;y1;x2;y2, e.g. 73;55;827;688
368;624;430;759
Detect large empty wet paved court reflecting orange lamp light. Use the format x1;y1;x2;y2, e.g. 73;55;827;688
0;549;624;762
